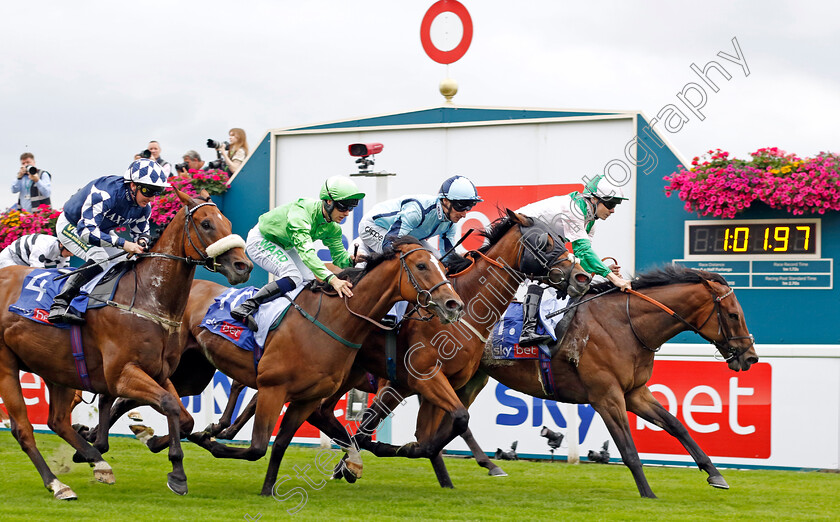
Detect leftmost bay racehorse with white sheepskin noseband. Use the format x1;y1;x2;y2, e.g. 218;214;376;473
0;189;253;499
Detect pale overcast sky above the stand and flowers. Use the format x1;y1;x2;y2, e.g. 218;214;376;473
0;0;840;209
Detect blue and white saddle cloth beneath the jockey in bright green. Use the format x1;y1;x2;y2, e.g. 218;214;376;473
199;286;304;352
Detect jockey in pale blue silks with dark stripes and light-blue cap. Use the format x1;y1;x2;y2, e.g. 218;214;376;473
356;176;483;256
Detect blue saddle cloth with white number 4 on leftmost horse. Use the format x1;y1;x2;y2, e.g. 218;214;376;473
9;263;130;328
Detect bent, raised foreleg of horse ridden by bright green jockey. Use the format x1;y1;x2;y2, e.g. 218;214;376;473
188;385;286;460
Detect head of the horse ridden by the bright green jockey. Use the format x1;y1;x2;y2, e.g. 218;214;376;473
393;236;464;324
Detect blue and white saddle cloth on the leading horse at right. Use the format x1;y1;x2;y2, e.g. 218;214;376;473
490;299;564;360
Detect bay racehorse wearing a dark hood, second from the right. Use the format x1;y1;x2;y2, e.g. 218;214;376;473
288;210;590;488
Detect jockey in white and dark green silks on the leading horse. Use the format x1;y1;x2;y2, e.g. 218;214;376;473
517;175;630;346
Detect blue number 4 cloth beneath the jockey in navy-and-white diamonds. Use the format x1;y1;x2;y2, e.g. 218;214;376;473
9;268;116;328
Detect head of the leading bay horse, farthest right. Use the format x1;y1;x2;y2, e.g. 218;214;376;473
700;278;758;372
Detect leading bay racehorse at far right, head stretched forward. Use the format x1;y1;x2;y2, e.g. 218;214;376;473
434;265;758;498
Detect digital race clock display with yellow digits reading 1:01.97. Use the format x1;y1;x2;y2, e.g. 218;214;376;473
688;222;819;255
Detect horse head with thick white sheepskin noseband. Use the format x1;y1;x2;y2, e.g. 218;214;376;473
156;187;254;285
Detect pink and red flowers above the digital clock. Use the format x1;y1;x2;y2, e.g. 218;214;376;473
663;147;840;218
